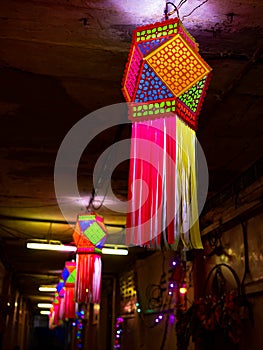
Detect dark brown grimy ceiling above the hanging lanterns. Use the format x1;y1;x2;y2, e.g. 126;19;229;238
0;0;263;306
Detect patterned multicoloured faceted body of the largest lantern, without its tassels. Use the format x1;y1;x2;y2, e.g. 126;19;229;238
123;18;211;130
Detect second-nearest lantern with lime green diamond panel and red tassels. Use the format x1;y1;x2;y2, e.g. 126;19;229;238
73;213;107;304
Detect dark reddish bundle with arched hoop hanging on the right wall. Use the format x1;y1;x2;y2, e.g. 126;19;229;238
176;263;253;350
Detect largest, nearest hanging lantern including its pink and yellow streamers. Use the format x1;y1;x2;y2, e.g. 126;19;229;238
122;18;211;248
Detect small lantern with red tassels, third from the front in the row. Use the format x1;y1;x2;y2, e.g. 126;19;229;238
61;261;76;319
